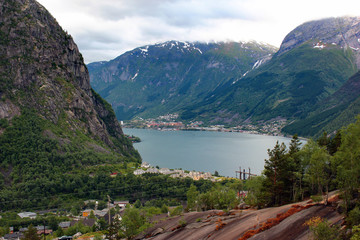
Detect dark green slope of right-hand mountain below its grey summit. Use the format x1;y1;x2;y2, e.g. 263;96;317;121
182;42;357;123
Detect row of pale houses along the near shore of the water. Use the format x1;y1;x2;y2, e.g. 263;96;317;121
134;162;216;181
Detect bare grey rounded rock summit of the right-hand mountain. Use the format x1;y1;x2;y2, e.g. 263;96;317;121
278;17;360;68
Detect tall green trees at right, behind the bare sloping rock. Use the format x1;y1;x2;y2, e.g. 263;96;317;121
245;118;360;210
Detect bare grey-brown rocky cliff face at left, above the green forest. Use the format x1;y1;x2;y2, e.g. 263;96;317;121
0;0;137;157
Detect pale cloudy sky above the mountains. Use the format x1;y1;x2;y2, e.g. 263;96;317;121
37;0;360;63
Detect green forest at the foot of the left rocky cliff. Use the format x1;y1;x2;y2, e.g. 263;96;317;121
0;111;211;211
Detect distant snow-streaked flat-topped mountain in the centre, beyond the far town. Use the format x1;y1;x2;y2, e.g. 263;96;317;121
88;41;276;120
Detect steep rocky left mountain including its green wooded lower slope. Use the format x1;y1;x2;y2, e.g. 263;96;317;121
0;0;141;210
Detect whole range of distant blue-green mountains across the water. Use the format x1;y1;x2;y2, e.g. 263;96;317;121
88;17;360;136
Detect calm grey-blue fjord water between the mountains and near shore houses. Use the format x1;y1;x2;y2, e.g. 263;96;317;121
123;128;291;177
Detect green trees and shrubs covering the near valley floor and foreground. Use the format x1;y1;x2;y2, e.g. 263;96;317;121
0;113;360;239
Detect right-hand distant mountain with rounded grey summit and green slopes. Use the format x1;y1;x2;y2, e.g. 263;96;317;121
182;17;360;128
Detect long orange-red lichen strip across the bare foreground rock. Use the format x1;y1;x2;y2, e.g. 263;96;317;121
239;205;312;240
